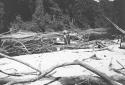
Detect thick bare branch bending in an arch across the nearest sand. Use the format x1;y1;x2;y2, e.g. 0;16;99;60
6;61;122;85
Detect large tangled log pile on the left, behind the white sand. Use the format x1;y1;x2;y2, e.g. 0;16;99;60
1;31;62;56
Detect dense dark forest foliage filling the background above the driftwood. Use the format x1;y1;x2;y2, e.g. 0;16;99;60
0;0;119;32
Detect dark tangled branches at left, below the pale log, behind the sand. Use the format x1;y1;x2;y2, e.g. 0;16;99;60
2;38;54;56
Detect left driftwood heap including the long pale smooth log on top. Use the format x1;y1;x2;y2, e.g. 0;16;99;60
0;31;62;56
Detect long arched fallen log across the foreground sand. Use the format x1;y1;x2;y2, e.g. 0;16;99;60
2;51;124;85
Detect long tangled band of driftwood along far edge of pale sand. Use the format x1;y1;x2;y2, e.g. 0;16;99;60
1;32;117;56
